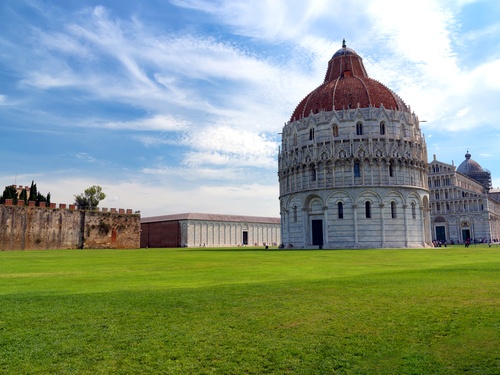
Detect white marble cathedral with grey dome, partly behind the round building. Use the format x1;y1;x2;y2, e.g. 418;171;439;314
428;151;500;243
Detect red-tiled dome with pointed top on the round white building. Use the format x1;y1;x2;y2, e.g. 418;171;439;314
291;40;409;121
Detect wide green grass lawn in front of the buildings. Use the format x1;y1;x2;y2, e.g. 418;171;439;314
0;246;500;374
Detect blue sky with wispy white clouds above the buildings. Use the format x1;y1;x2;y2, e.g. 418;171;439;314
0;0;500;216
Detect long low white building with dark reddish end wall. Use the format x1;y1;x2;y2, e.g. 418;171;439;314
141;213;281;247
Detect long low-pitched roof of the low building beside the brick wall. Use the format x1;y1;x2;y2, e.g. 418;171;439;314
141;212;281;224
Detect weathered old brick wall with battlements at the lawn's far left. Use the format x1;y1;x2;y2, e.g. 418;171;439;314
0;205;140;251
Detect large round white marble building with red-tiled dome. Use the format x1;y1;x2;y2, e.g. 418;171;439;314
278;41;431;248
